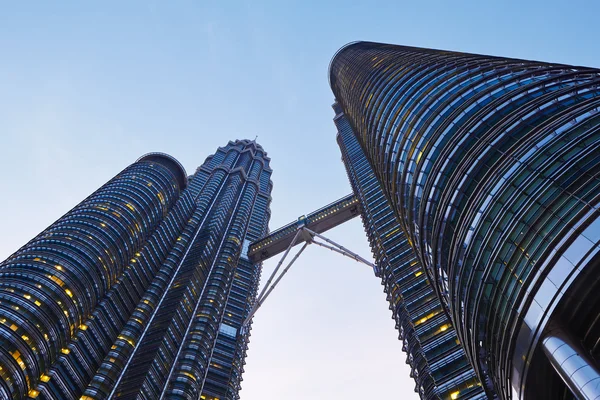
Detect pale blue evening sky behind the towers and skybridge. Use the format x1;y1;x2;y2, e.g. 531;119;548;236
0;0;600;400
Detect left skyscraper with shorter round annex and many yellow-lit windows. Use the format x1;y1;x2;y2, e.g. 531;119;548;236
0;140;272;400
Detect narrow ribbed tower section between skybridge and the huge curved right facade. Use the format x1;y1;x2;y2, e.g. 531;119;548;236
334;104;486;399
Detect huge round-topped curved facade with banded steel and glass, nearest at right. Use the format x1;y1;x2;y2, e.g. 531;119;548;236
330;42;600;399
